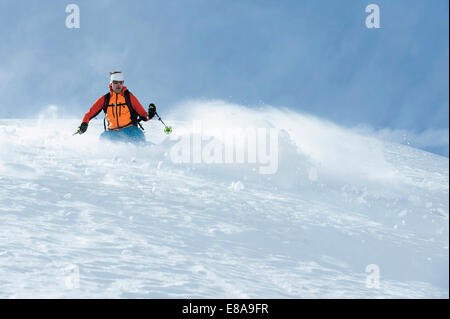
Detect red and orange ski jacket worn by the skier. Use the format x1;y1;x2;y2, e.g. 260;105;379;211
83;84;148;130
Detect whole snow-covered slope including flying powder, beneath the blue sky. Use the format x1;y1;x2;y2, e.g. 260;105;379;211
0;101;449;298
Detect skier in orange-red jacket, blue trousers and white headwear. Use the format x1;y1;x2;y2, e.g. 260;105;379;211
77;71;156;143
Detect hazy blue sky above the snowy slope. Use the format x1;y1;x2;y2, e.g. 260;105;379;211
0;0;449;156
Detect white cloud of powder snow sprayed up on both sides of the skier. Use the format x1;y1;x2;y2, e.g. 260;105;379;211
0;100;444;190
